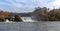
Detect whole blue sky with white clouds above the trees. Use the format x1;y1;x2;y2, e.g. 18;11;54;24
0;0;60;13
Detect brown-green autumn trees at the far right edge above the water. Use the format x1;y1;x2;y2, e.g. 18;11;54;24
47;9;60;21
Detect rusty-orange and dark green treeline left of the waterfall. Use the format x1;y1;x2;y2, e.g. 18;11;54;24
0;11;22;22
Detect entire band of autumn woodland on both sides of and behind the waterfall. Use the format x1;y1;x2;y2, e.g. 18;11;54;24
0;7;60;22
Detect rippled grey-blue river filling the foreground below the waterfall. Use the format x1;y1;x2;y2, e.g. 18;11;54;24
0;22;60;31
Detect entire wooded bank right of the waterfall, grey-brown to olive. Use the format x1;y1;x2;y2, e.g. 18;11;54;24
33;7;60;21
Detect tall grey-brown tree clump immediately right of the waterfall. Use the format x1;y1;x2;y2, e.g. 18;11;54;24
34;7;47;21
